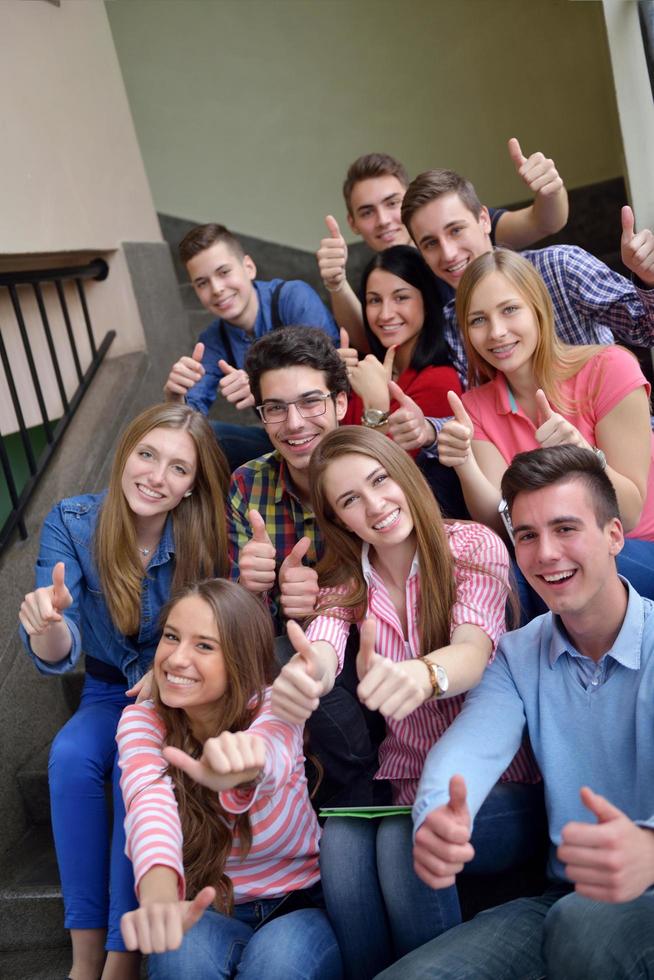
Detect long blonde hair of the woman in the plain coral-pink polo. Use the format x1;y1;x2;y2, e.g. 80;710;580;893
456;248;606;412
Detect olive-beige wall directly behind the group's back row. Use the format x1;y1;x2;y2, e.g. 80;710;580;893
107;0;623;249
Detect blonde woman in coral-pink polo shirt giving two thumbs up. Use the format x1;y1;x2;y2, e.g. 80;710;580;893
438;249;654;598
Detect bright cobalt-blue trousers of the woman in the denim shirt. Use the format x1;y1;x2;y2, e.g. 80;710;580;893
48;674;138;950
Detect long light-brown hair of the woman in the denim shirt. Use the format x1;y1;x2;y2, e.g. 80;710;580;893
95;402;229;635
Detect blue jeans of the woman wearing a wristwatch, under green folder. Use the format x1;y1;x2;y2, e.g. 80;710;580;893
320;783;545;980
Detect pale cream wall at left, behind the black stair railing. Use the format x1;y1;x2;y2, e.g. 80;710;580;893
0;0;161;433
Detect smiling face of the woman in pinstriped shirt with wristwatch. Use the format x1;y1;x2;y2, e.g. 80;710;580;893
324;453;415;553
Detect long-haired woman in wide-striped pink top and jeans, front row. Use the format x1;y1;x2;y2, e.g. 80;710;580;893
117;579;342;980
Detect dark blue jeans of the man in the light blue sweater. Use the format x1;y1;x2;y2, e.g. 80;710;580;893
378;884;654;980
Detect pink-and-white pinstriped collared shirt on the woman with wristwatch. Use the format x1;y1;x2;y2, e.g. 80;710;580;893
307;523;540;805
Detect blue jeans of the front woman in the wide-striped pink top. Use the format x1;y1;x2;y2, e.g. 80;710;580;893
148;899;342;980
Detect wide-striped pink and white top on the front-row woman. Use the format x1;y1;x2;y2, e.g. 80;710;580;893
116;690;320;904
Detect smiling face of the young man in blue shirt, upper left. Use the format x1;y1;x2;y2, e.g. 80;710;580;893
186;242;259;330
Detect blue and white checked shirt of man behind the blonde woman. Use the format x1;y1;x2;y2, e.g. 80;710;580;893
425;245;654;455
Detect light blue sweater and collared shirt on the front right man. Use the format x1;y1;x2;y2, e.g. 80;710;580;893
413;582;654;879
